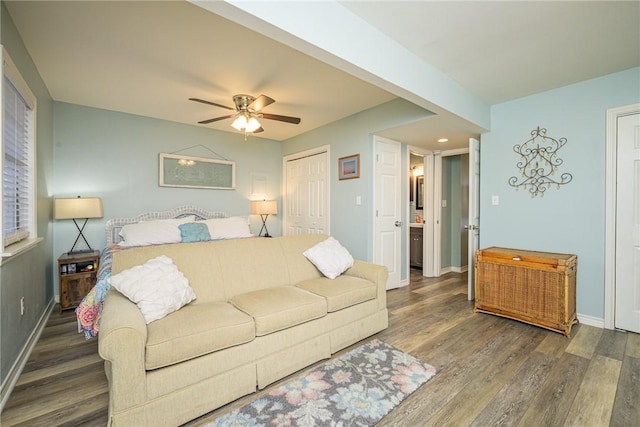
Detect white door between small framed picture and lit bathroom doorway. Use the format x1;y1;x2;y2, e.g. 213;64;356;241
373;136;406;289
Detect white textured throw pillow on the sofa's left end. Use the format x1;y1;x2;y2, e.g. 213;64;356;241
110;255;196;324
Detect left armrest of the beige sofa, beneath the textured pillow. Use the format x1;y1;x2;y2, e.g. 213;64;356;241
98;289;147;413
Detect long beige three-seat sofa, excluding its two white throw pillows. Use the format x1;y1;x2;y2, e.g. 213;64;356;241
98;235;388;426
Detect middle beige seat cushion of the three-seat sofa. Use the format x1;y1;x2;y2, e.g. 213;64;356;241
230;286;327;336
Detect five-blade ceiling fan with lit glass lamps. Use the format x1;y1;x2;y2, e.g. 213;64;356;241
189;95;300;139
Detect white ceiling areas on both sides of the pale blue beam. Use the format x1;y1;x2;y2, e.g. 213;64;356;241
6;1;640;149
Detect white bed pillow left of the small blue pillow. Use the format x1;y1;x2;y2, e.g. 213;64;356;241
118;215;195;246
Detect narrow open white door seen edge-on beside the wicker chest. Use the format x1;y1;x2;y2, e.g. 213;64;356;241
467;138;480;301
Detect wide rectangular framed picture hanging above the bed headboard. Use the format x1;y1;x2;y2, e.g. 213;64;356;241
158;153;236;190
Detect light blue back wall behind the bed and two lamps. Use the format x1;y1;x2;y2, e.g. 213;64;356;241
53;102;282;294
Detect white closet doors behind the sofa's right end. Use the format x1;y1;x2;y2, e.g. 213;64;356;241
283;152;328;235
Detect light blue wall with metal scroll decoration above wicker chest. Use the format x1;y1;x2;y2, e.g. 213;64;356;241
480;68;640;319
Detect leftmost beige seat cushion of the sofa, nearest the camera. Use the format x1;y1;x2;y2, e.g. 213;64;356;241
145;302;255;370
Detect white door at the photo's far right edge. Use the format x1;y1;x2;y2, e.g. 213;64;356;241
615;114;640;333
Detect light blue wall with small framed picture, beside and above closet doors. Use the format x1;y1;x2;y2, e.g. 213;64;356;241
282;99;431;266
